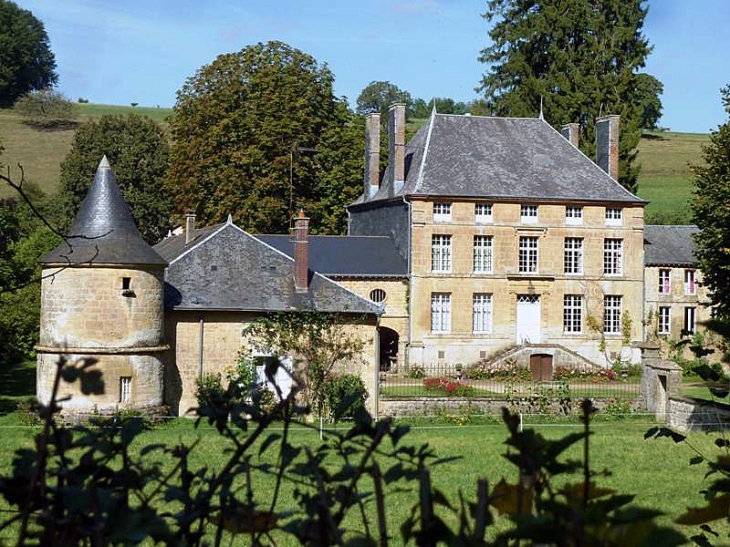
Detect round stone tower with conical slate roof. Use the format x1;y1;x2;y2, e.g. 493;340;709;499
36;156;168;412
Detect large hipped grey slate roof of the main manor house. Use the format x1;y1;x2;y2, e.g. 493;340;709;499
354;113;646;205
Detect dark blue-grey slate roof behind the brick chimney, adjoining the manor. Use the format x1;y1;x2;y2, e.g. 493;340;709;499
256;235;408;277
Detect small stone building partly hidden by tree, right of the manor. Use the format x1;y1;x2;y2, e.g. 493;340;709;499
644;225;712;340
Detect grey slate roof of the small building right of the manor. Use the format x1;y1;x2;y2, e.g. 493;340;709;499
644;224;700;266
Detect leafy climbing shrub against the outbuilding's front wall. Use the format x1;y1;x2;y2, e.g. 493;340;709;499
243;311;364;418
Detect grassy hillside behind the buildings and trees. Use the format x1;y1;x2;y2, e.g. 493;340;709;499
0;107;708;224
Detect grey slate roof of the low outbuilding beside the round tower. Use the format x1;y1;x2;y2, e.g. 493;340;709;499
157;222;382;314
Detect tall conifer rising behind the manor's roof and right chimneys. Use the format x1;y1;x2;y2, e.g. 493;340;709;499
477;0;651;192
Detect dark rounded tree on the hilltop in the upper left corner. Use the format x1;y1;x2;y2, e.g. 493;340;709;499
0;0;58;107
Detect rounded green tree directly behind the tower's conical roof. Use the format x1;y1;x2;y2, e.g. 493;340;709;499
59;114;172;244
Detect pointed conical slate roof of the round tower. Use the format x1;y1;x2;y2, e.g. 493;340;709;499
41;156;167;266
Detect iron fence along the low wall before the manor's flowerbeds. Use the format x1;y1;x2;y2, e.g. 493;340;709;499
379;364;641;400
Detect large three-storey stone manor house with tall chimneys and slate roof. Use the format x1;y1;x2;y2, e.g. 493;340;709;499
348;105;646;366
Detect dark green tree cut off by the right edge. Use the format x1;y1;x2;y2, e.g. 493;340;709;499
691;86;730;319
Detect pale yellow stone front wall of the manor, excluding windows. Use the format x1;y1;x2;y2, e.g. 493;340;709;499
409;199;643;365
